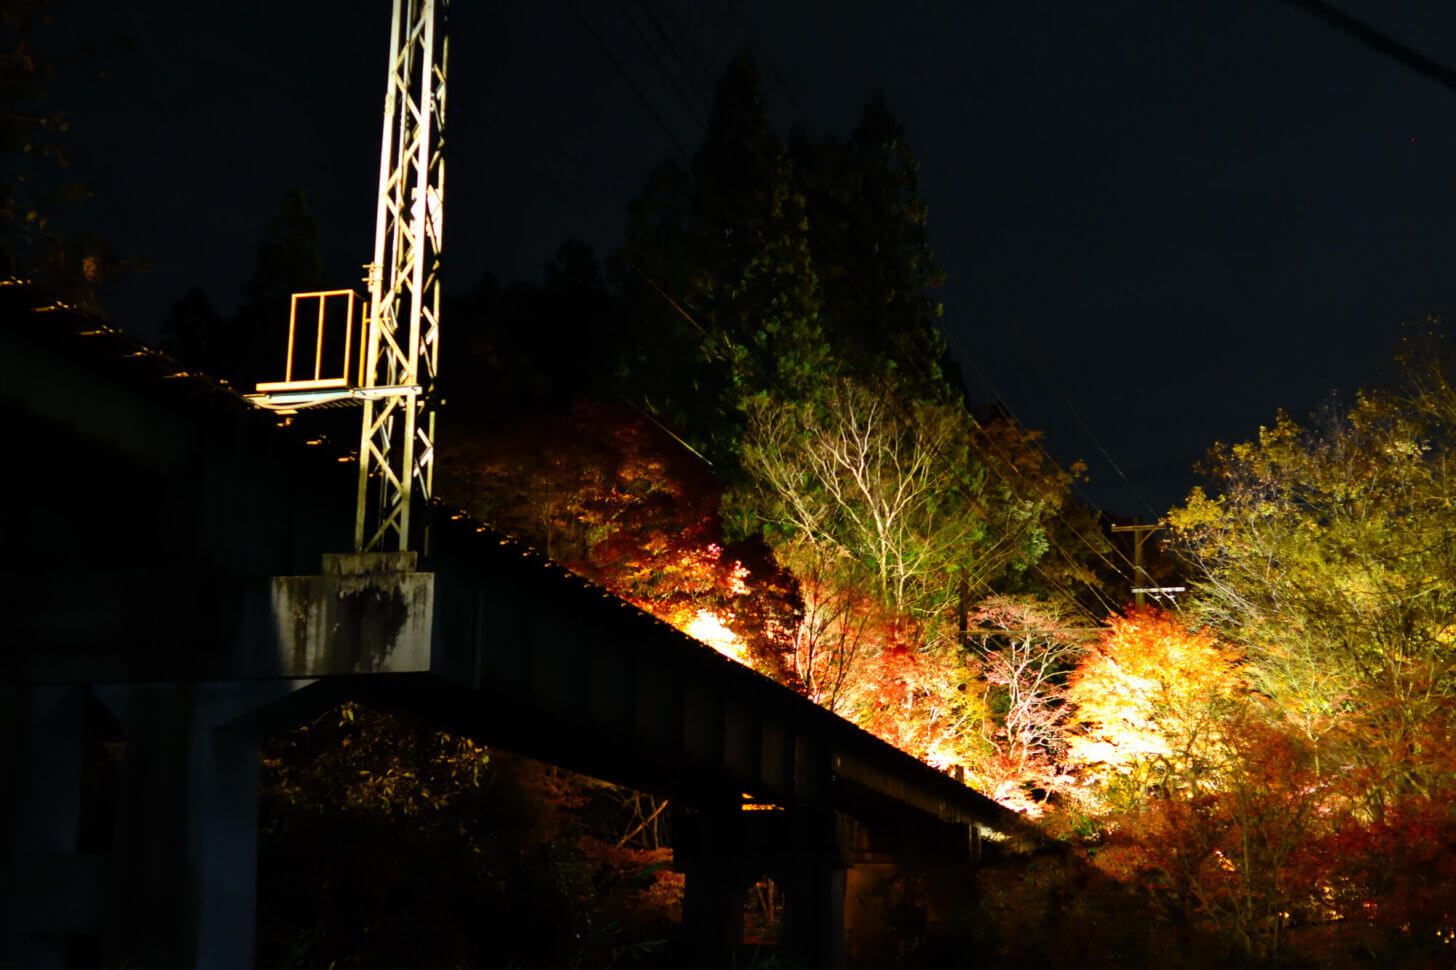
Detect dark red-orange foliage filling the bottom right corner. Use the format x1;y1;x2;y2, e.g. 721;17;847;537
1092;684;1456;967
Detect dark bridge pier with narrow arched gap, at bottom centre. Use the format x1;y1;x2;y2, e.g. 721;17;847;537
673;807;855;970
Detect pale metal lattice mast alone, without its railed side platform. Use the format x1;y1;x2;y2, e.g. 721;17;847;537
354;0;448;551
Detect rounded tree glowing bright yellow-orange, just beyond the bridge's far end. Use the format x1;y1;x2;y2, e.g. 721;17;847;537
1066;607;1239;801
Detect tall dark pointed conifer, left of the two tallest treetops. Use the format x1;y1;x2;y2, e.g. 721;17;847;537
617;52;836;466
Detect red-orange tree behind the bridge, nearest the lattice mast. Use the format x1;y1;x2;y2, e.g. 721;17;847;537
441;402;798;683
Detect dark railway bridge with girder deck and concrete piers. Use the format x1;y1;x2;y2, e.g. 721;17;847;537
0;283;1042;970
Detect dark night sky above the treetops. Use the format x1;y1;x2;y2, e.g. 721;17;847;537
57;0;1456;520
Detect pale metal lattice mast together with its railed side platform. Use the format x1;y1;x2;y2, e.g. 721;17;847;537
248;0;448;552
